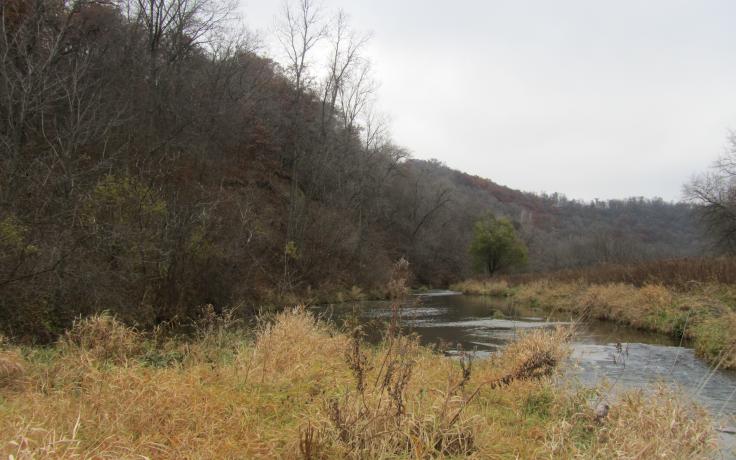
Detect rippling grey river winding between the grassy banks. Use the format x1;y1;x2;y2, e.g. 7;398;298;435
315;291;736;458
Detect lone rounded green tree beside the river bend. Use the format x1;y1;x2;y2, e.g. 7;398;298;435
470;216;527;276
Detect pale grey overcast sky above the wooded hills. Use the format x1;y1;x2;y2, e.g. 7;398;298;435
240;0;736;200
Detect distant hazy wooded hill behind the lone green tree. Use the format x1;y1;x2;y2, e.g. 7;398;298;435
394;160;711;279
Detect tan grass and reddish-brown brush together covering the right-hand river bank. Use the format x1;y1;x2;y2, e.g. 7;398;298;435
452;258;736;368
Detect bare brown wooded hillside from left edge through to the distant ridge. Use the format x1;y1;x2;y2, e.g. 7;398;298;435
0;0;707;340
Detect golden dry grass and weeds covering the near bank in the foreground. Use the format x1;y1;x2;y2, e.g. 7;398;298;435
0;309;715;458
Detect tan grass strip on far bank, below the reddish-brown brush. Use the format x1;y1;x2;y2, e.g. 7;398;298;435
452;280;736;369
